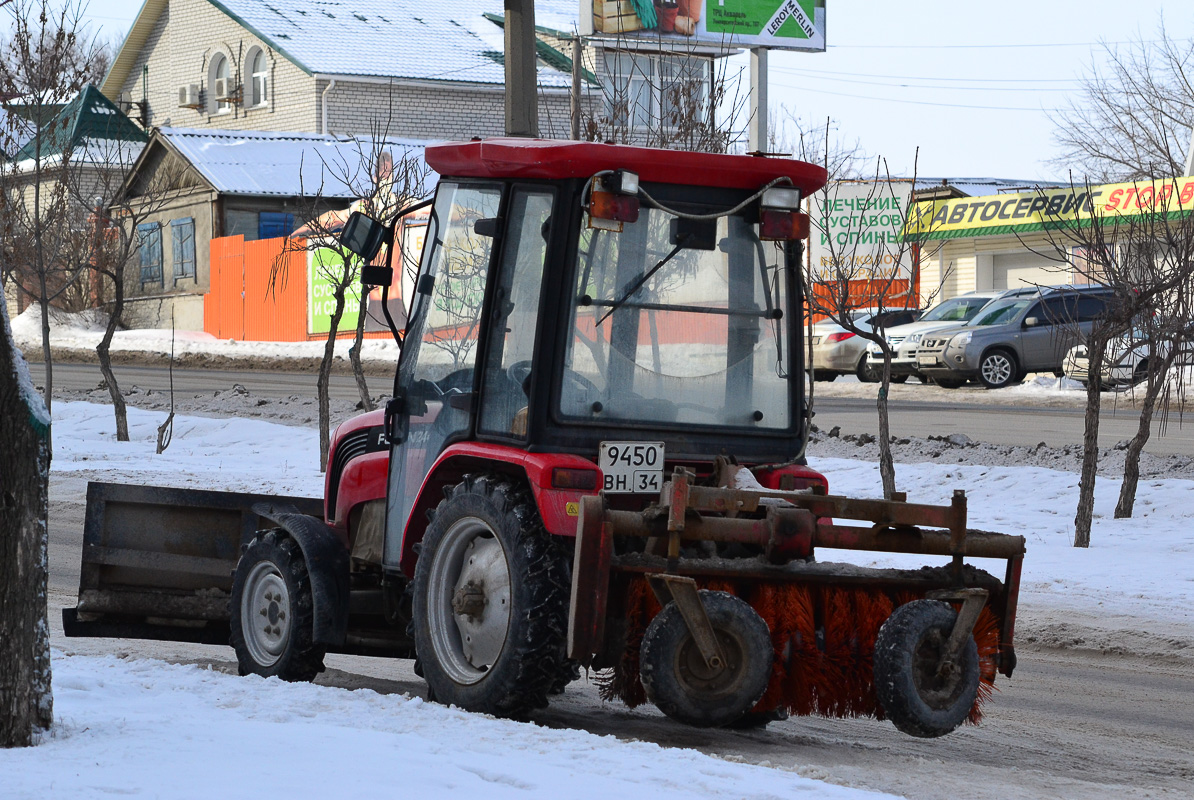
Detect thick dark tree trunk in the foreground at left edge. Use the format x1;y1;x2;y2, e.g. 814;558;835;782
0;303;54;747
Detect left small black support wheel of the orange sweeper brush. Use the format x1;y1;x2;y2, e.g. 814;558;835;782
639;590;775;727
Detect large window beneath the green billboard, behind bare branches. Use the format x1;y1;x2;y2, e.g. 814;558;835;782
605;53;713;130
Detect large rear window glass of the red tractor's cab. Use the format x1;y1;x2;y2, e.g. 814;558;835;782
560;208;790;429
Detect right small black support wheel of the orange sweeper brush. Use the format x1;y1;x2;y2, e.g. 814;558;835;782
874;599;979;739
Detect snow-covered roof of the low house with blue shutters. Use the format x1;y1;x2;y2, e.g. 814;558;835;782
158;128;435;199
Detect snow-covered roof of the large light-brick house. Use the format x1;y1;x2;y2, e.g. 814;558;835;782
104;0;578;96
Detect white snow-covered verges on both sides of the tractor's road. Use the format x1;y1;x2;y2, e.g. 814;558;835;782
0;402;1194;799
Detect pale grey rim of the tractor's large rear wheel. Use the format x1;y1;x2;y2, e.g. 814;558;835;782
427;517;510;684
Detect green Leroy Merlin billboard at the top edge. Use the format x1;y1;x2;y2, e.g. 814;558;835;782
580;0;825;50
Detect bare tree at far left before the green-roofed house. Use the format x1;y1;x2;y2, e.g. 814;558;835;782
0;0;99;407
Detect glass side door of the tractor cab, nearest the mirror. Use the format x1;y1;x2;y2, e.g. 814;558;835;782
383;181;503;567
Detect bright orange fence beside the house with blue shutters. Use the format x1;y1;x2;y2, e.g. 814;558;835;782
203;236;390;341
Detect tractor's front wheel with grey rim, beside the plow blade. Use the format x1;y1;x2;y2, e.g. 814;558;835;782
228;530;326;681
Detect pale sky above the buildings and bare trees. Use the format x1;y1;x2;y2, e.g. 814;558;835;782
74;0;1194;180
